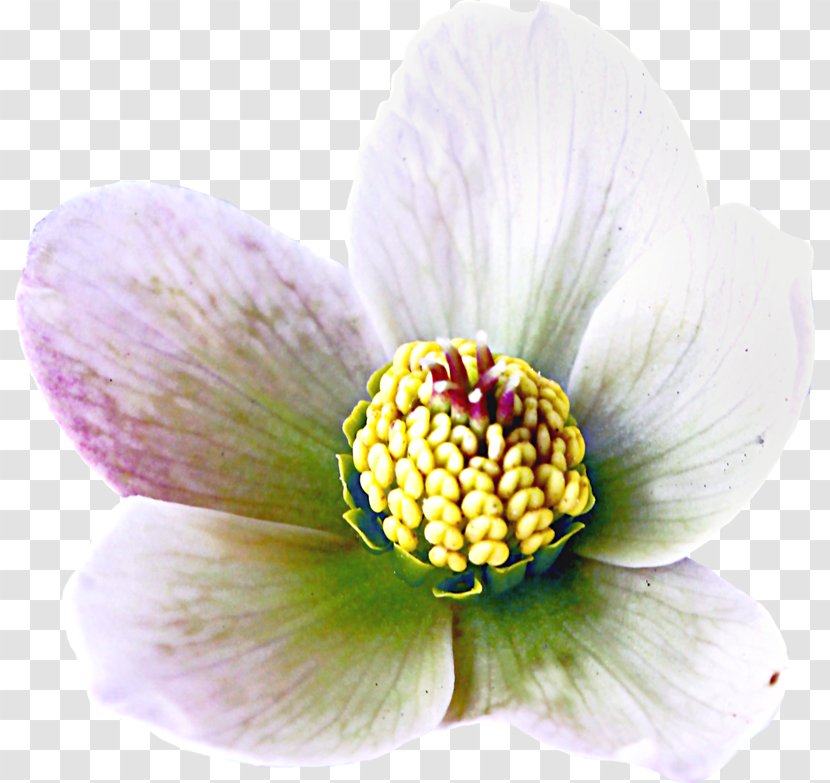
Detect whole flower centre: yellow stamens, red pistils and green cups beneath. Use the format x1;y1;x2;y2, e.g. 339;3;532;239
340;337;594;595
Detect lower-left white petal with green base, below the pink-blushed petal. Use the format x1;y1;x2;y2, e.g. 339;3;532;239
64;498;453;764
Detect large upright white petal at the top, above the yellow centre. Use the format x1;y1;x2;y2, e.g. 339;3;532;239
350;3;708;379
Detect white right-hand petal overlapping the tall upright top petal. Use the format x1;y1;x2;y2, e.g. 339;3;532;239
569;206;813;565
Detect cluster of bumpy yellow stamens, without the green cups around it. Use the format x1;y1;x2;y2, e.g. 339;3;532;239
352;340;592;572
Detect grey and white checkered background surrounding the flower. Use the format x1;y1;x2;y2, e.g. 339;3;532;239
0;0;830;781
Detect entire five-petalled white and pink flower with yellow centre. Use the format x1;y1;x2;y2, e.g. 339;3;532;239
17;3;813;780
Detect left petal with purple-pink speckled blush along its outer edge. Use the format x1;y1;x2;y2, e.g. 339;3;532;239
18;184;384;529
